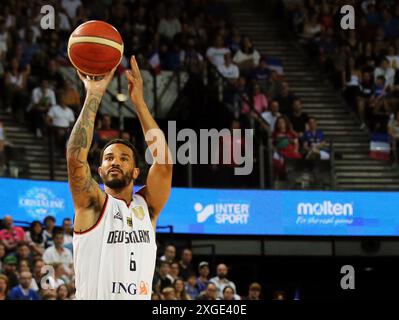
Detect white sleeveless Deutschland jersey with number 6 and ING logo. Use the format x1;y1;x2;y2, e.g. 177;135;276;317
73;194;157;300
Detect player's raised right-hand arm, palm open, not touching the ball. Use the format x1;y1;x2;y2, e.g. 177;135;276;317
126;56;173;226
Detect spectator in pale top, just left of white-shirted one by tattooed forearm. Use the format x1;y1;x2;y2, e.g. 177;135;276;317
27;79;57;138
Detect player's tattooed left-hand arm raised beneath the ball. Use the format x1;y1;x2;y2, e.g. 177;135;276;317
67;69;115;232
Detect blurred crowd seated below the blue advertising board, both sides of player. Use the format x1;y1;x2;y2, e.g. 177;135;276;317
0;216;278;300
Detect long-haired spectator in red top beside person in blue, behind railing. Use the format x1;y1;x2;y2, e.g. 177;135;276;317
273;116;302;159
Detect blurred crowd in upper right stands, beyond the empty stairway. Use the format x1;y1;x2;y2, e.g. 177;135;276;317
286;0;399;151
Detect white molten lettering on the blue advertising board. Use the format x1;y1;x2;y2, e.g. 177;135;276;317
297;201;353;216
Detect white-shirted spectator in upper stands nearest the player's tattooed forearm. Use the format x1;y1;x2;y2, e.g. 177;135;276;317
47;95;75;155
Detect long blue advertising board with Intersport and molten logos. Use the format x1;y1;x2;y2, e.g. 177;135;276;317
0;178;399;236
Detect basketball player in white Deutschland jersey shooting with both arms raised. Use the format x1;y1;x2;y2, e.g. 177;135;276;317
67;57;172;300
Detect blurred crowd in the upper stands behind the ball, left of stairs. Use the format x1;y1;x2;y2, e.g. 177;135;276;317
0;0;329;185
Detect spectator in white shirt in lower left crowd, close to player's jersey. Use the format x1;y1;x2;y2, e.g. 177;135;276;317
43;230;73;276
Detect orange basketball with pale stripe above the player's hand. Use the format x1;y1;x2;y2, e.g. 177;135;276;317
68;20;123;76
